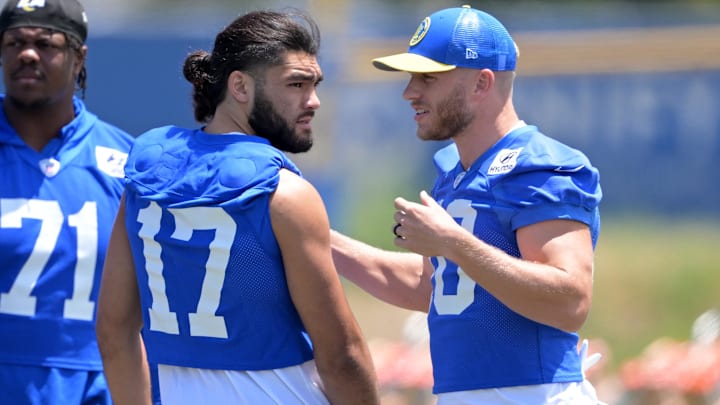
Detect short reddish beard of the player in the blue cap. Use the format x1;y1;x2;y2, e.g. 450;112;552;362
417;86;475;141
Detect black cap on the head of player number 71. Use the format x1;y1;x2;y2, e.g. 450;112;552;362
0;0;87;43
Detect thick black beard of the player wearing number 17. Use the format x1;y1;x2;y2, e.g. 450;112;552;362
248;87;313;153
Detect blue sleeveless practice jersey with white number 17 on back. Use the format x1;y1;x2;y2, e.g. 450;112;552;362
126;127;312;370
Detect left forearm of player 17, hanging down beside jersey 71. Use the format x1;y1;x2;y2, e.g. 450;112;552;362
99;334;152;405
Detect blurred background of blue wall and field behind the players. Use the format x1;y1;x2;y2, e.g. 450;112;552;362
12;0;720;405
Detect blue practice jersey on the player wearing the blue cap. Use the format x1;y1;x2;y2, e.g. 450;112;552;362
428;126;601;393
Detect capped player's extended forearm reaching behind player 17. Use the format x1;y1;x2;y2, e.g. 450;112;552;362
331;231;430;312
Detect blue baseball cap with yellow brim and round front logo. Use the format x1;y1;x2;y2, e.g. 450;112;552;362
372;6;518;73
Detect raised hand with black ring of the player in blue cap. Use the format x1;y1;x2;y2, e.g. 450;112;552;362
393;191;462;257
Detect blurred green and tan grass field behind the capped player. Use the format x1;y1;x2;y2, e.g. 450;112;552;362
338;205;720;369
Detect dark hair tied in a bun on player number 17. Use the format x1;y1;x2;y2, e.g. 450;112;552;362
183;10;320;122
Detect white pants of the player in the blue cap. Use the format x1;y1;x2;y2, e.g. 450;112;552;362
437;380;603;405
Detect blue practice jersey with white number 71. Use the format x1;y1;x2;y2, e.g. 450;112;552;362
0;97;133;370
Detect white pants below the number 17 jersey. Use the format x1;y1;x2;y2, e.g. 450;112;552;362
158;360;329;405
